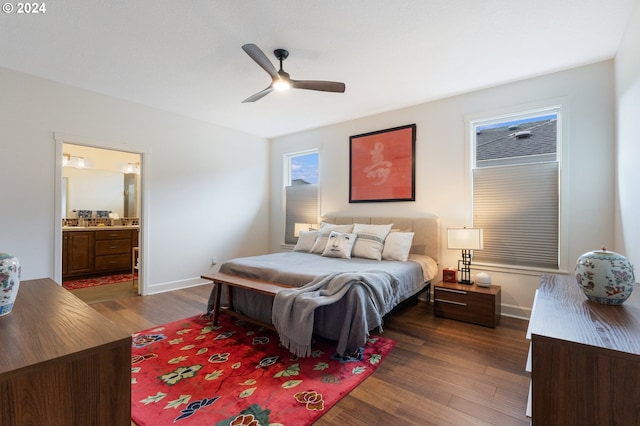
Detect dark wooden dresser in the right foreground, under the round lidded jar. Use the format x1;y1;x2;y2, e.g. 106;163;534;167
527;275;640;426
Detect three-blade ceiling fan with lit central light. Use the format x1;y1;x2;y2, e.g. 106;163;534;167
242;43;345;103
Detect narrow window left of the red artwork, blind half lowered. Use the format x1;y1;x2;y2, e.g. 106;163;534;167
284;150;318;244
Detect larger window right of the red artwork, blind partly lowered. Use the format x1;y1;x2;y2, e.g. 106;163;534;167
471;107;561;270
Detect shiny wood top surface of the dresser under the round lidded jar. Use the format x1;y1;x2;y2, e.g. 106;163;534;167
529;275;640;355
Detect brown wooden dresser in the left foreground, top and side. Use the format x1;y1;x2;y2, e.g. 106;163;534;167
0;278;131;426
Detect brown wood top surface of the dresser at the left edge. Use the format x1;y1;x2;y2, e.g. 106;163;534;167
0;278;131;376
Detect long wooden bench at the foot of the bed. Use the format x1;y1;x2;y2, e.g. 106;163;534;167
201;272;292;330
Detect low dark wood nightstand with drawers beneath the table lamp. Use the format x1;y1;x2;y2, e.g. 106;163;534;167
433;281;501;327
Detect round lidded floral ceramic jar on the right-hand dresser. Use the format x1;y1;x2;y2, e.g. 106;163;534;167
575;247;635;305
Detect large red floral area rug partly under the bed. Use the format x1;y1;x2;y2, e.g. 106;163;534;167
131;315;395;426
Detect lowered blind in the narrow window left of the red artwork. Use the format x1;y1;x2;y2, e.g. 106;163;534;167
284;183;318;244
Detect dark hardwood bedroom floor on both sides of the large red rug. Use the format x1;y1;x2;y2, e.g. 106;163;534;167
91;285;530;426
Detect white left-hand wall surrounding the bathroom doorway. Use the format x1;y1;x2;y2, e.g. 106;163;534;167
0;69;269;293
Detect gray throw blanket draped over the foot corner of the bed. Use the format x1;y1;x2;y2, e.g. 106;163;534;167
272;271;398;357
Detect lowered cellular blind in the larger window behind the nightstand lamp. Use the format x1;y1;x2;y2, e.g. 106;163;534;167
473;161;559;269
